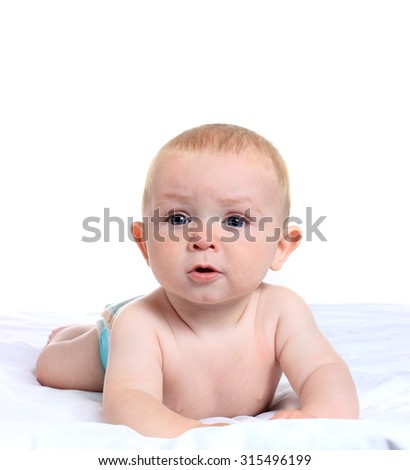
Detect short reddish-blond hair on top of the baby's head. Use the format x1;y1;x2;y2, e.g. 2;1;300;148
142;124;290;219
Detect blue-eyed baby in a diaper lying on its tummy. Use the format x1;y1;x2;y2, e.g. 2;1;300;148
37;124;358;437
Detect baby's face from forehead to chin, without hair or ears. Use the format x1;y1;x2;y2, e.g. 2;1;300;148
145;152;282;304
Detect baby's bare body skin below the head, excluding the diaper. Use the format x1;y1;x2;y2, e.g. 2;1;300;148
38;284;357;436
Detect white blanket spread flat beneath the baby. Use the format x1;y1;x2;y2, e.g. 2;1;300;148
0;304;410;450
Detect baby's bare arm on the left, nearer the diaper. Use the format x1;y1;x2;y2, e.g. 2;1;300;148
103;311;221;437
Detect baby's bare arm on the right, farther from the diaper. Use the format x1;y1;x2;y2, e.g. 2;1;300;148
274;293;359;418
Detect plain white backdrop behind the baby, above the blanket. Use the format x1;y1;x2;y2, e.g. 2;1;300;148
0;0;410;313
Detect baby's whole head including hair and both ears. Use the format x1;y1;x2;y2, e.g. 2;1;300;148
133;124;300;305
